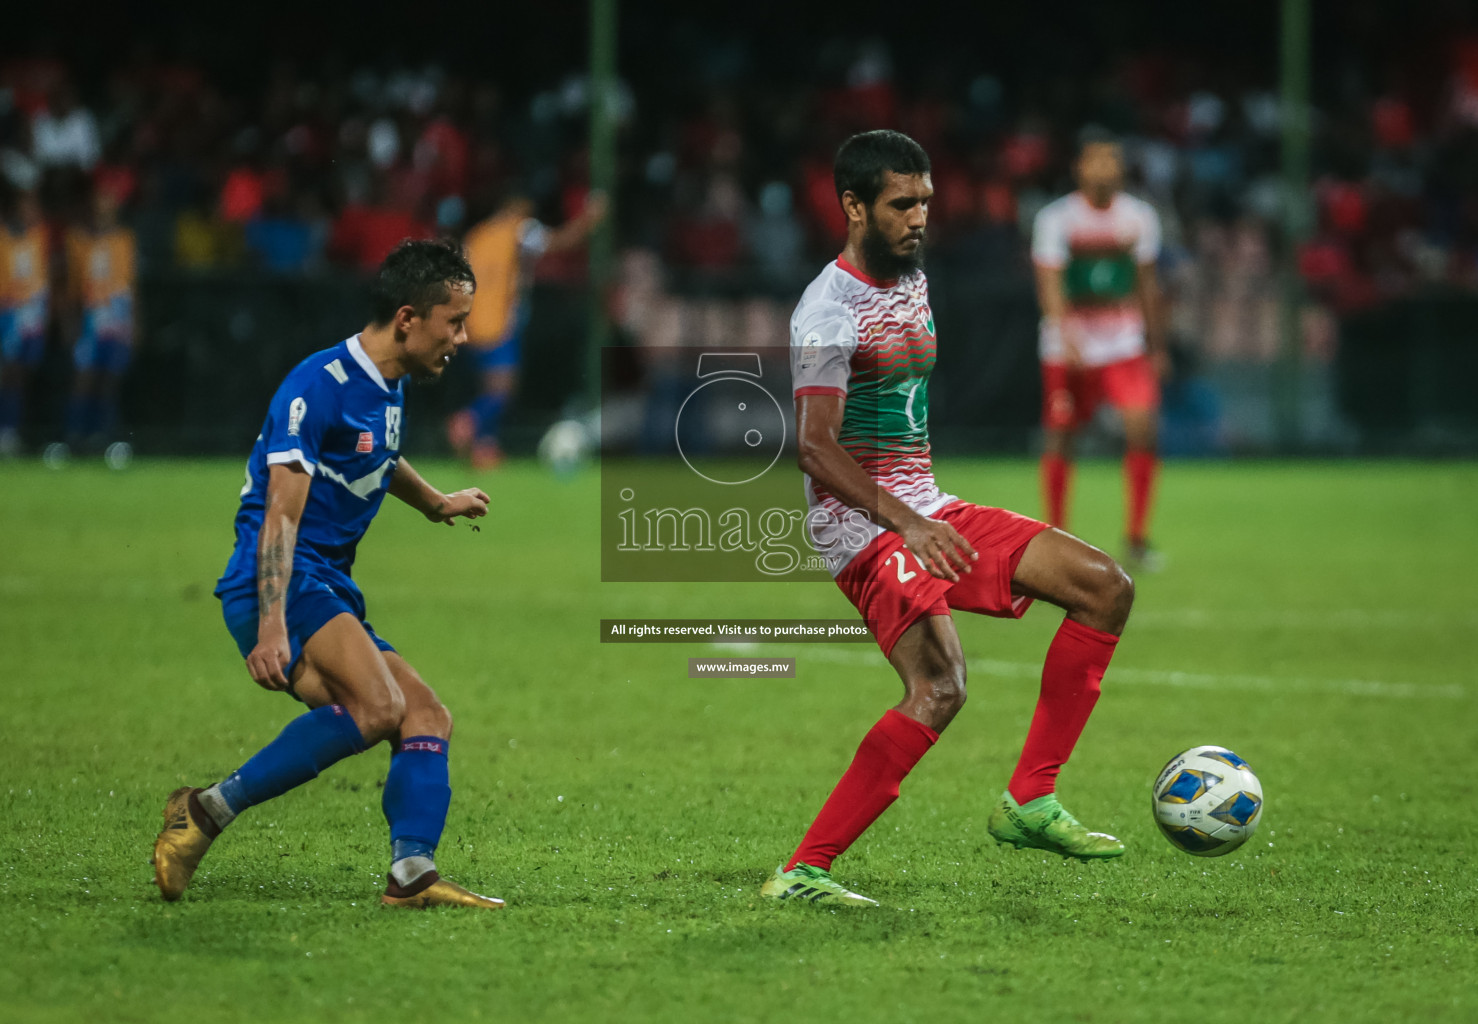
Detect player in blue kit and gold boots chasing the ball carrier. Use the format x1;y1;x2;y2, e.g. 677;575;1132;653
154;241;503;909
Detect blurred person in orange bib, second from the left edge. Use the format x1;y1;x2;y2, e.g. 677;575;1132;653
67;188;136;458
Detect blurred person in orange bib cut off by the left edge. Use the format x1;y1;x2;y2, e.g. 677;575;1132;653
0;191;52;457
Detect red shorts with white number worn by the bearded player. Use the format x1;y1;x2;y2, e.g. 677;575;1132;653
837;501;1048;655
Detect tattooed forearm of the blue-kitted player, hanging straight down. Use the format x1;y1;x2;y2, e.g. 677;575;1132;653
247;462;313;690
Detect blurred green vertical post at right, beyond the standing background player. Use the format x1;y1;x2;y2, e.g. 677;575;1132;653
1273;0;1312;451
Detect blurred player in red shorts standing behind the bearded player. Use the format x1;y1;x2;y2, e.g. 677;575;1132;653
1032;130;1169;569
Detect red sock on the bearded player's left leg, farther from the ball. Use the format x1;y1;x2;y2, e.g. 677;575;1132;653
785;708;939;870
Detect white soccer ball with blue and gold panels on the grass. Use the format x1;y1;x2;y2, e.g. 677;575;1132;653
1151;746;1262;857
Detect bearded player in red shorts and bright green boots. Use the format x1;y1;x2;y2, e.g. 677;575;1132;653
761;132;1134;906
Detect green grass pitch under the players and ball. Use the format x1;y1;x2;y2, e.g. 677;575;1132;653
0;460;1478;1023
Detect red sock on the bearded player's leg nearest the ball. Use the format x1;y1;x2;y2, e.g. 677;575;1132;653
1008;619;1119;804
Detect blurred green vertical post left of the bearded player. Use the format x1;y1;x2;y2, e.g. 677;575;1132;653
585;0;616;409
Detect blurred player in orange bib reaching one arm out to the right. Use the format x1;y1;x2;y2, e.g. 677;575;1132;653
446;192;606;470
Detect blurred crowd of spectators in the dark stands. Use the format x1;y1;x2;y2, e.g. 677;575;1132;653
0;9;1478;367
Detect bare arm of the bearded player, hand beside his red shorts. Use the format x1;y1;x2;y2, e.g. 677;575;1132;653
795;395;980;582
